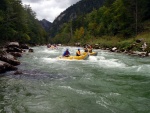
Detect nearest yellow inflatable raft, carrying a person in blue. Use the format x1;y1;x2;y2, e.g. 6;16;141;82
58;52;89;60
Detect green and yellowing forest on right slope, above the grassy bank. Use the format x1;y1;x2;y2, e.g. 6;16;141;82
52;0;150;46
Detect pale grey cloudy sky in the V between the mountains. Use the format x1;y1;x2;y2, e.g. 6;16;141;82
22;0;80;22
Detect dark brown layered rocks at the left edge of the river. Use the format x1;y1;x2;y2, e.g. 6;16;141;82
0;42;33;74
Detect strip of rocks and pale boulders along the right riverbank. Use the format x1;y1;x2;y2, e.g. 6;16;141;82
74;38;150;57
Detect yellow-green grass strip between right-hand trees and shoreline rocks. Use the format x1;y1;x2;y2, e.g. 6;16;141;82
69;30;150;50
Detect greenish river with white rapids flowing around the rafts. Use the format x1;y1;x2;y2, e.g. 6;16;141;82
0;46;150;113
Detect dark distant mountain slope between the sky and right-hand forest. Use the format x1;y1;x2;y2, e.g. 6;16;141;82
50;0;104;37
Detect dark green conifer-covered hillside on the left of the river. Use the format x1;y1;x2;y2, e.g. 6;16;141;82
0;0;47;44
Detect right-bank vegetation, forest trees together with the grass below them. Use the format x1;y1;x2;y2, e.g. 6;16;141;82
50;0;150;54
